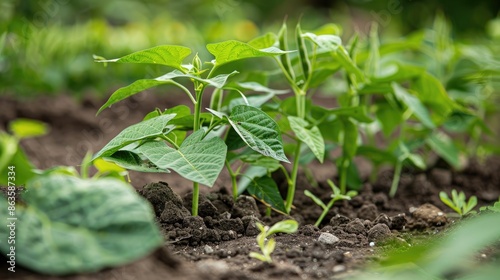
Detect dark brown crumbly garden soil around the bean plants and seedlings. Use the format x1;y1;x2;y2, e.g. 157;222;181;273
0;95;500;279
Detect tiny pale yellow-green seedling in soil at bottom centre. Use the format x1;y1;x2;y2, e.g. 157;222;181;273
250;220;299;263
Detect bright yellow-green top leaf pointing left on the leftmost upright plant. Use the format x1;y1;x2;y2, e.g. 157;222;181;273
96;45;191;69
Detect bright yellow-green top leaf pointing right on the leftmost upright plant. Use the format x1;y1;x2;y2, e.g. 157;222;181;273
207;40;287;67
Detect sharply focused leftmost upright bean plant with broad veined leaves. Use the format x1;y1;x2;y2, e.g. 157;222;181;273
93;41;288;216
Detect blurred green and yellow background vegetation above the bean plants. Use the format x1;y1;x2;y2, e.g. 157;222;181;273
0;0;500;97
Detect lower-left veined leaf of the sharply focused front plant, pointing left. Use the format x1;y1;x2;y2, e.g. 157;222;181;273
92;114;175;160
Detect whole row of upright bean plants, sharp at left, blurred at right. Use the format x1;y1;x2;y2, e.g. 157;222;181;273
93;17;500;221
